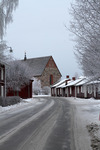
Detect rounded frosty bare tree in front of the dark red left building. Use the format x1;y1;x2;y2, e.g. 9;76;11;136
6;61;32;91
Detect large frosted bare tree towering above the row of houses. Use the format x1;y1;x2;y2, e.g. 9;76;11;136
70;0;100;78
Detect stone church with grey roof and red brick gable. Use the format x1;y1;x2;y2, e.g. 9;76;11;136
22;54;62;87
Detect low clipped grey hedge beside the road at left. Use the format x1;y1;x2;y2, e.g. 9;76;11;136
0;96;21;107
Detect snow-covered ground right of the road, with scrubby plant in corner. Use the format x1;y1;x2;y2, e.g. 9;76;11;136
67;98;100;150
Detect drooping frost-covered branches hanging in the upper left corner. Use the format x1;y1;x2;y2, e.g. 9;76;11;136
0;0;19;62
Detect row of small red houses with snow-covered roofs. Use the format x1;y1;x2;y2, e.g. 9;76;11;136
51;76;100;99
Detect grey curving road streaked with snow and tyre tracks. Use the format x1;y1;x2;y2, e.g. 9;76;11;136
0;97;72;150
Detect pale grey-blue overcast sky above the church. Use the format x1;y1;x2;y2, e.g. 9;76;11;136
5;0;81;78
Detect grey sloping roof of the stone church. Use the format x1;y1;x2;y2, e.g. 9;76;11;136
22;56;52;77
